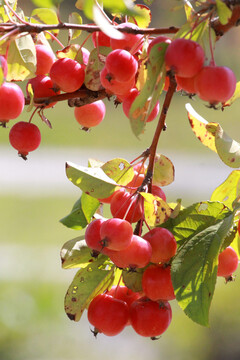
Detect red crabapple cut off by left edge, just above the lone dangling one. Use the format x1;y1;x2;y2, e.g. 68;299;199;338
0;82;25;123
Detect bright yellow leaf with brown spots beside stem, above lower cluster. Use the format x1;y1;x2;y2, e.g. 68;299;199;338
140;192;172;226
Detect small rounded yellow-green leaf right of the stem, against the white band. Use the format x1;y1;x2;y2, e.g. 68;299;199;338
153;154;175;186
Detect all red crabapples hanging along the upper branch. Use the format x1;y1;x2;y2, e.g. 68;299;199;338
0;23;236;159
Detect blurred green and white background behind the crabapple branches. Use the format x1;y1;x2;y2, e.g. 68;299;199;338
0;0;240;360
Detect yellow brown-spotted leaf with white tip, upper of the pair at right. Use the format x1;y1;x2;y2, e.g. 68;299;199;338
186;104;217;152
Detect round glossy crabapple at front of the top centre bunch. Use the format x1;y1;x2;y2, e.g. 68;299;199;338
105;49;138;82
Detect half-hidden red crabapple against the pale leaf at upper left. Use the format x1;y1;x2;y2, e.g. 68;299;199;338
36;44;55;75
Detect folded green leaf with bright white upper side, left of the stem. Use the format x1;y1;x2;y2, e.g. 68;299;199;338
66;163;117;199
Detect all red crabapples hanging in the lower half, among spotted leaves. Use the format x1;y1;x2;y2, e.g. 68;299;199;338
82;160;240;339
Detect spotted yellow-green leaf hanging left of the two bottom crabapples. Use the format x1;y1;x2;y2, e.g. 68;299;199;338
64;255;115;321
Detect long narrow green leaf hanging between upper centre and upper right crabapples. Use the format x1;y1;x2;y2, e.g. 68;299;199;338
129;43;168;137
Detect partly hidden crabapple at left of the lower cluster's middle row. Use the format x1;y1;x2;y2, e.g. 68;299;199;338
85;219;104;251
